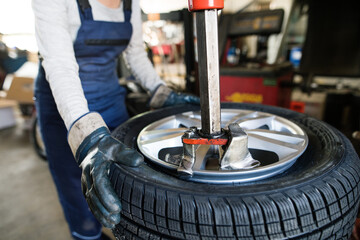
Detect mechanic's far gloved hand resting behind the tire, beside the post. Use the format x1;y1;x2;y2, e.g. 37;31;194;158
150;85;200;108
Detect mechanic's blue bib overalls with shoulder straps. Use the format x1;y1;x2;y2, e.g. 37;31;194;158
35;0;132;239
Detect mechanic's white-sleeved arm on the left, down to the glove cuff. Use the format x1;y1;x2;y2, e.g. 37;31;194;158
32;0;89;129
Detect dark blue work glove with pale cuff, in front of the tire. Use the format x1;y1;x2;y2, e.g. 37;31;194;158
68;113;144;228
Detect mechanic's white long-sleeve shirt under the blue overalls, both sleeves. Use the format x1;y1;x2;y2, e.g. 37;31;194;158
32;0;163;129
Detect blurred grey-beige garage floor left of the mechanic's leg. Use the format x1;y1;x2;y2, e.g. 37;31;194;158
0;113;115;240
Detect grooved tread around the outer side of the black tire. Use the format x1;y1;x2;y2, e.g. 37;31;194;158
110;105;360;240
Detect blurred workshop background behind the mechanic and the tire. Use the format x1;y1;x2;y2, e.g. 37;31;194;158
0;0;360;240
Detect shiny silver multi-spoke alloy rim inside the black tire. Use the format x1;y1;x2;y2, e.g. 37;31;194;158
137;109;308;184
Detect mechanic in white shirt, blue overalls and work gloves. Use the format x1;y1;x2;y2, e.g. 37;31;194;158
32;0;199;239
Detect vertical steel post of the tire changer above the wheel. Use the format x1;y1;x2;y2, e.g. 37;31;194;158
196;9;221;135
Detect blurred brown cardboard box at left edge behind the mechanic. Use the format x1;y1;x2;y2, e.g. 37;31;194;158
6;76;34;104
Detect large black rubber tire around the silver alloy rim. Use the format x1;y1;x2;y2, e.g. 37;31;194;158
110;103;360;240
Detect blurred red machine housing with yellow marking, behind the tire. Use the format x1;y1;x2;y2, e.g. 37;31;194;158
220;64;293;108
